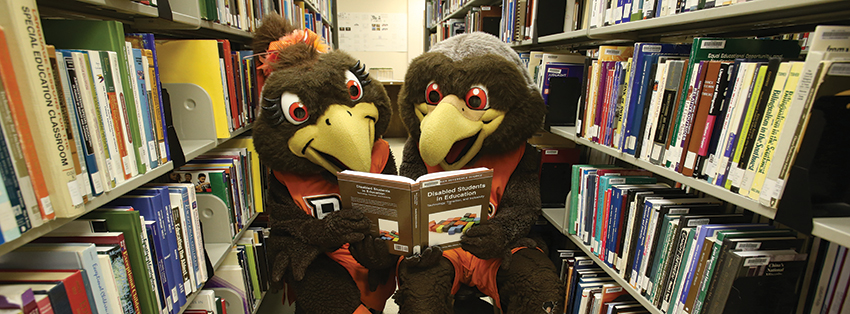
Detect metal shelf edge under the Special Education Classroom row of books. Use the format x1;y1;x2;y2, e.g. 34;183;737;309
0;161;174;255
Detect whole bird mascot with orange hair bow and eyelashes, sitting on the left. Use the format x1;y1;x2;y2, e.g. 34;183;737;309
253;16;398;314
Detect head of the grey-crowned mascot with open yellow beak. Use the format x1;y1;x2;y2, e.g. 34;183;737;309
399;32;545;170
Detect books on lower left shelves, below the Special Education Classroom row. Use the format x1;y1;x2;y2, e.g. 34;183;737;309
0;137;268;314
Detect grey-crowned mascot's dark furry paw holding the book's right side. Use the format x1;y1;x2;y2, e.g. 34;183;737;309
460;223;510;259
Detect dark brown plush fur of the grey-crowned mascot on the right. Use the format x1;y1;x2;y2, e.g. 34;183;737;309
395;33;563;313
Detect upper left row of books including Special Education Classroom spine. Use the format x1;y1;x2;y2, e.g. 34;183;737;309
0;6;182;234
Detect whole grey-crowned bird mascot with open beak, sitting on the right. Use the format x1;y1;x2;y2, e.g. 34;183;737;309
396;33;563;313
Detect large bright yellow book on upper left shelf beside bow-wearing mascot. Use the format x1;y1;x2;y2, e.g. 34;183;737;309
156;39;230;138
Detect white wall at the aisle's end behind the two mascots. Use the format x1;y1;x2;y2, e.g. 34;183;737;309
337;0;425;81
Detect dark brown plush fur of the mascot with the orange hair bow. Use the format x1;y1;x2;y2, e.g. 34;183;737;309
253;16;398;314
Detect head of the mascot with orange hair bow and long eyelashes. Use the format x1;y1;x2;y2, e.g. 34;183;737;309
253;15;392;174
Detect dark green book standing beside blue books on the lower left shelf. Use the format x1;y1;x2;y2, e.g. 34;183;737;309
83;207;159;314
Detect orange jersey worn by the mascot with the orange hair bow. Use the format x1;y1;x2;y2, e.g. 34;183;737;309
274;139;395;313
